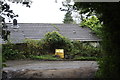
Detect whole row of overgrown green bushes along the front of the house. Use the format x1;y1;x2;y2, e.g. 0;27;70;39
3;31;101;60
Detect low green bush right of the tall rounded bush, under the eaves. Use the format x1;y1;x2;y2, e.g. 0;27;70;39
73;41;101;57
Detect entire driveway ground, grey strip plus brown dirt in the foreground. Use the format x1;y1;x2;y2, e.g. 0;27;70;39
3;60;98;78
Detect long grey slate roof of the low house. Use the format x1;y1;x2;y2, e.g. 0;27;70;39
8;23;100;43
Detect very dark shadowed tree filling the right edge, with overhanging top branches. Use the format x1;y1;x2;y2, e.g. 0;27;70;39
74;2;120;78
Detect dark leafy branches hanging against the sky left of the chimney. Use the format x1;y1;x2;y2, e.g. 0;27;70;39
0;0;32;41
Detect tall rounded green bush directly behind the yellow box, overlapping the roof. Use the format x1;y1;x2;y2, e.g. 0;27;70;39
41;31;72;53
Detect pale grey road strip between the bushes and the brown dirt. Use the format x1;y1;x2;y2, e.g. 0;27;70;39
4;60;98;70
